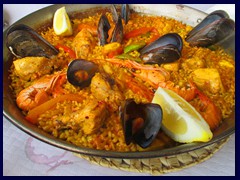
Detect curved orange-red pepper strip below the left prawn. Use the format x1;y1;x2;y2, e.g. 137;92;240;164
26;94;84;124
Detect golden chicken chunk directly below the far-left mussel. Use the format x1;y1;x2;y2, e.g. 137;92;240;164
13;57;53;80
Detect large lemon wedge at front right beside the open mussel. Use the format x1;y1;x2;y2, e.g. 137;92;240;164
152;87;213;143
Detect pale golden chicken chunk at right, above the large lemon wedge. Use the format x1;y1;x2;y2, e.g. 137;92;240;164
191;68;224;93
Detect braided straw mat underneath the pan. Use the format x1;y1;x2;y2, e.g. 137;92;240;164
74;137;229;175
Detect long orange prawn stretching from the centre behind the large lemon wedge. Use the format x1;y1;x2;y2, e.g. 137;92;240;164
100;58;196;102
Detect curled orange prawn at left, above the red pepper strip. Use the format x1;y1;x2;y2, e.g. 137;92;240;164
16;73;66;111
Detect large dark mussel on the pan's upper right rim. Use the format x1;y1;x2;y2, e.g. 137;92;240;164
186;10;235;47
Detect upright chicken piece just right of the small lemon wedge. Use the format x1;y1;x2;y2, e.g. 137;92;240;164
72;29;95;59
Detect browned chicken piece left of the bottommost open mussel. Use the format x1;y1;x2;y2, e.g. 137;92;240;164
72;100;108;134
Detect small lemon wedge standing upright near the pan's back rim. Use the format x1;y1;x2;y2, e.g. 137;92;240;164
53;7;73;36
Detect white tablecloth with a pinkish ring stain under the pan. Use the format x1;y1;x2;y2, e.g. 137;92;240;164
3;4;235;176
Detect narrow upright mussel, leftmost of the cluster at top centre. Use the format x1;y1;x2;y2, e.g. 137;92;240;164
97;14;111;46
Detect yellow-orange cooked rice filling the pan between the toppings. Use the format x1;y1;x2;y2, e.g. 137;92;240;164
10;9;235;151
